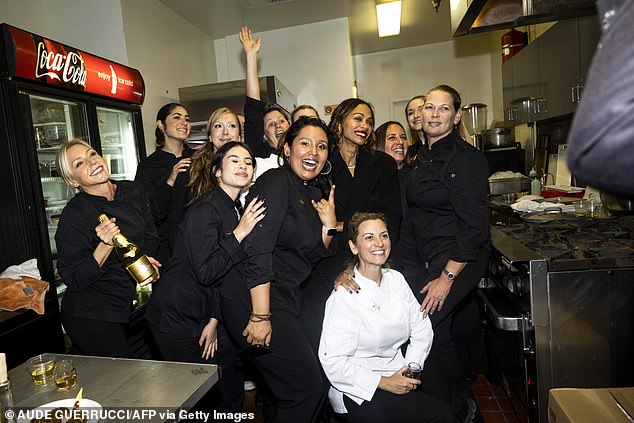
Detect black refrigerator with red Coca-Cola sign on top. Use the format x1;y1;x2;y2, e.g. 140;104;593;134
0;24;145;367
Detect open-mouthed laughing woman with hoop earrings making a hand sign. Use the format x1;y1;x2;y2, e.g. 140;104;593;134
221;117;337;423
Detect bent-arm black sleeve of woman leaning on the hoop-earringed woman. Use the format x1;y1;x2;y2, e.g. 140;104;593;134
180;203;246;286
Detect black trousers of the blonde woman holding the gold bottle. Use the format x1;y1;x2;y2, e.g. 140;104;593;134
60;311;133;358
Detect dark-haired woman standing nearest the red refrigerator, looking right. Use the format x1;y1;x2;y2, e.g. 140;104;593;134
134;103;194;268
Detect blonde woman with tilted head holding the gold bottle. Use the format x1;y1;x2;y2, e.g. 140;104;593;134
55;139;160;358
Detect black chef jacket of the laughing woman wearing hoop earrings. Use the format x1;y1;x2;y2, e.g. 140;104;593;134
230;165;336;315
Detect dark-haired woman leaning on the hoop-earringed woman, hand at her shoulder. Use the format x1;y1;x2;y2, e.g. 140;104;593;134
145;142;265;412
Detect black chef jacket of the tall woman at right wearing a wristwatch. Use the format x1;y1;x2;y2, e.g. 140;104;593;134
407;133;489;262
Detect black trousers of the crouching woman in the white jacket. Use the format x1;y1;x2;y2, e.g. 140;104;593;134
337;389;456;423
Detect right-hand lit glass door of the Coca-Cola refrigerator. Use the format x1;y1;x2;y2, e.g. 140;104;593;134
97;106;139;181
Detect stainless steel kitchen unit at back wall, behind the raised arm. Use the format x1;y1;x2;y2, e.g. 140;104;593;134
178;76;297;122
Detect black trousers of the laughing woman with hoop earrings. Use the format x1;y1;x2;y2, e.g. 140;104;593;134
222;297;328;423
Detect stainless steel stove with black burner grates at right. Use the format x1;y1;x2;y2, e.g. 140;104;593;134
478;205;634;423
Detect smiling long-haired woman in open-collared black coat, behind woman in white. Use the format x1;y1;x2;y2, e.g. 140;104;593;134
304;98;401;319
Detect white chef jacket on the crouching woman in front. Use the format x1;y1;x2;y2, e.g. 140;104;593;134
319;268;434;414
